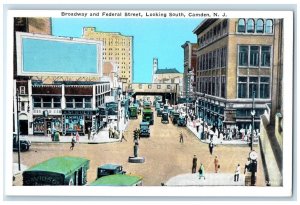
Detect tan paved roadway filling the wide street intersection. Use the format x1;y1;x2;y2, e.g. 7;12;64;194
13;108;265;186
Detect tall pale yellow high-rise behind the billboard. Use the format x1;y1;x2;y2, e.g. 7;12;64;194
82;27;134;83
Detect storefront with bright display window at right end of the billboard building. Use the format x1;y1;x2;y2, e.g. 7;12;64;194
62;110;96;135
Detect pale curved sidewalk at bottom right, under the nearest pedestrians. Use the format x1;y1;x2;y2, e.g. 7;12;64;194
165;173;245;186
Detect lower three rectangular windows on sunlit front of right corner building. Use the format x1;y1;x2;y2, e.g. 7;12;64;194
238;76;270;99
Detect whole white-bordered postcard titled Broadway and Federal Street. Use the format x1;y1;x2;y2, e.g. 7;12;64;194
4;10;293;197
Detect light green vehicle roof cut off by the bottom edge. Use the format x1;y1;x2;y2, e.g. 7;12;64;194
90;174;143;186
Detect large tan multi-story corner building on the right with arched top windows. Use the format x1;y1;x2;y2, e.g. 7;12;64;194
193;18;282;129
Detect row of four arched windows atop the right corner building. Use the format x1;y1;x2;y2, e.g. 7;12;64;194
237;18;273;34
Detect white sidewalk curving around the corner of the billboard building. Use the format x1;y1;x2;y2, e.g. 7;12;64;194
22;108;129;144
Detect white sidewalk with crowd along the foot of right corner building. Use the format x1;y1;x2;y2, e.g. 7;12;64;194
186;122;248;146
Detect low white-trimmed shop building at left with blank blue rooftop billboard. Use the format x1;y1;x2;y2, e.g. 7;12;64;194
14;32;111;135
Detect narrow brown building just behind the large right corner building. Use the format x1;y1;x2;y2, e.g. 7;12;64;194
181;41;198;96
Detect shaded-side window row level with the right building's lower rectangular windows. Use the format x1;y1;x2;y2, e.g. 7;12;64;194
196;76;226;98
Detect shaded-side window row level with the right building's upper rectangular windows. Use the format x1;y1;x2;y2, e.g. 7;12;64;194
198;47;227;70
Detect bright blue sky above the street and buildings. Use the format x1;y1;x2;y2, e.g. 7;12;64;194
52;18;202;83
